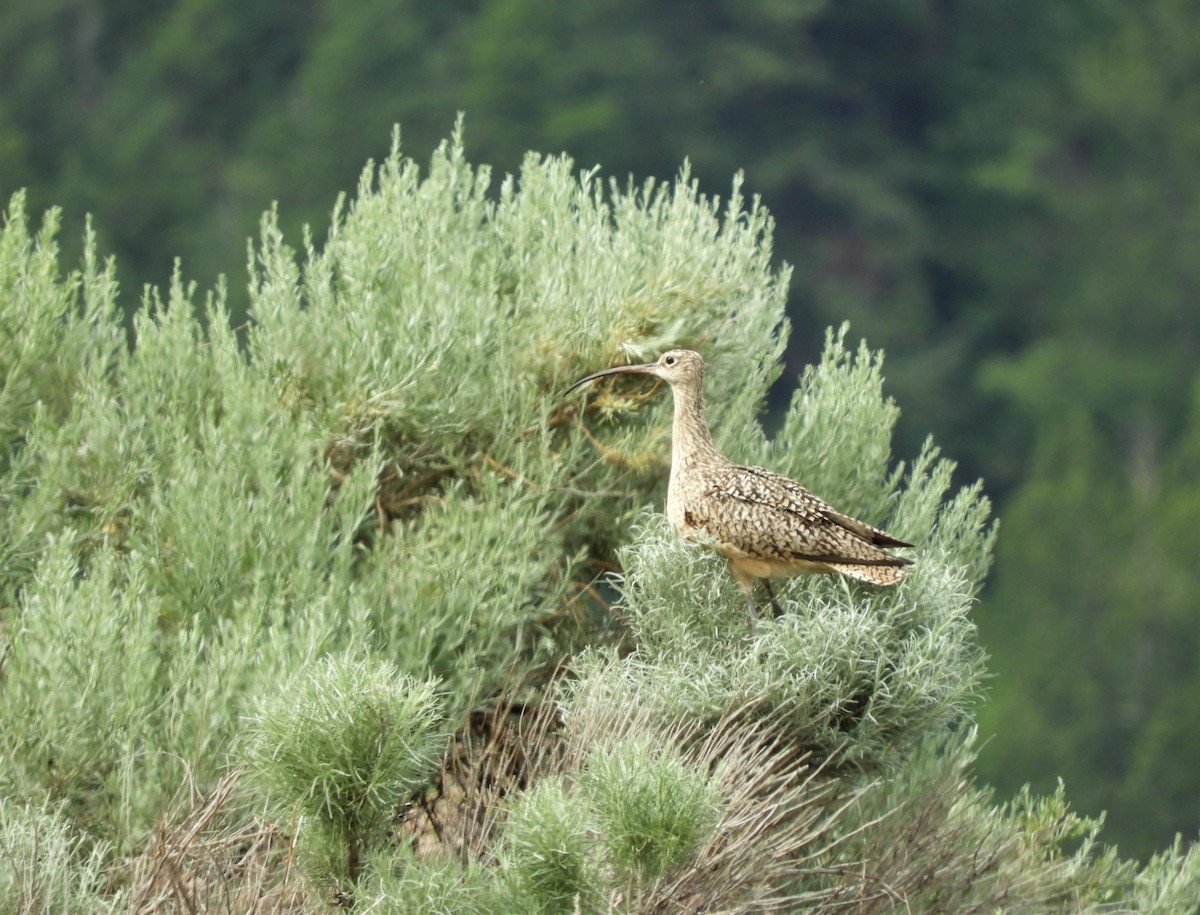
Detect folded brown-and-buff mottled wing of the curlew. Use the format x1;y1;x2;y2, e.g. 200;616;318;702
690;465;911;567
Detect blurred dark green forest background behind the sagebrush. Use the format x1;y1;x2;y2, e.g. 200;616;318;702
0;0;1200;856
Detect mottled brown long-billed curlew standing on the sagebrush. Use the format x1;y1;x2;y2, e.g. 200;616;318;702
563;349;912;622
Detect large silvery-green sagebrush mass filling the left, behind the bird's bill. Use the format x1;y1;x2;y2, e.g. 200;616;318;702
0;126;786;845
